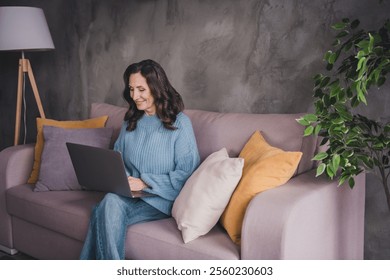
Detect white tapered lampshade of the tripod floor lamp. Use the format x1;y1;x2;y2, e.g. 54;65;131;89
0;7;54;51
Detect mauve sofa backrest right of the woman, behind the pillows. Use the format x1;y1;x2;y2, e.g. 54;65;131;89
185;110;316;174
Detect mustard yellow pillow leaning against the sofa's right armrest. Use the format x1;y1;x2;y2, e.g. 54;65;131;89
220;131;302;244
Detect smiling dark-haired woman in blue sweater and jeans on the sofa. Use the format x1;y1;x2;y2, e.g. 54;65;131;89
80;60;199;259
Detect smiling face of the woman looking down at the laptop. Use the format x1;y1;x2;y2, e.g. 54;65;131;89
129;73;156;116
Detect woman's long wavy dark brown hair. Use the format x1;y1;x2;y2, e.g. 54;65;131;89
123;59;184;131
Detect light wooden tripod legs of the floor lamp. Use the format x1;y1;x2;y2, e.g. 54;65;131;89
14;58;46;146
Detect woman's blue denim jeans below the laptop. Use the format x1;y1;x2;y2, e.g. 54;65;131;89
80;193;169;260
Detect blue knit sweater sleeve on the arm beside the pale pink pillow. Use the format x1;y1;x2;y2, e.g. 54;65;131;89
141;116;200;201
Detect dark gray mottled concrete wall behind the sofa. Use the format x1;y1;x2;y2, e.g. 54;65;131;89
0;0;390;258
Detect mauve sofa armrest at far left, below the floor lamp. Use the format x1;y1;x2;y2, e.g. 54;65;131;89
0;144;34;253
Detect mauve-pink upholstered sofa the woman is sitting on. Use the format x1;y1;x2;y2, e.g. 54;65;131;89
0;103;365;260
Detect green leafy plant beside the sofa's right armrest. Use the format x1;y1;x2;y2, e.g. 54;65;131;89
297;18;390;211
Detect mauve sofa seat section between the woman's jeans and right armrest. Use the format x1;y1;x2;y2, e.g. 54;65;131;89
126;218;240;260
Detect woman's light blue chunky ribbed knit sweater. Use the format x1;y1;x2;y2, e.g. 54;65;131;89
114;113;200;215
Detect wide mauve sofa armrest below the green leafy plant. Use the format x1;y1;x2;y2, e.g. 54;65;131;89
241;170;365;259
